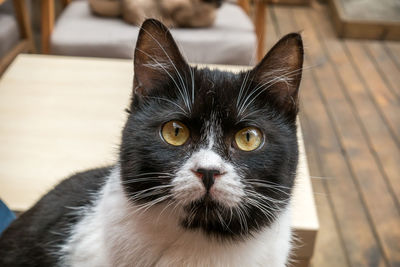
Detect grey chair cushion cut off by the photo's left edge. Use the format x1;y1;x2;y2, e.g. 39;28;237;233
0;12;20;58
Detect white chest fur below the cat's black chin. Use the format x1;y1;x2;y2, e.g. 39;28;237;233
62;169;291;267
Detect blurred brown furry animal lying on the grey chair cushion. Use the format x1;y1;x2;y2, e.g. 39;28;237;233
89;0;222;27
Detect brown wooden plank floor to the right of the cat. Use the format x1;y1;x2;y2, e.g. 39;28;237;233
266;3;400;267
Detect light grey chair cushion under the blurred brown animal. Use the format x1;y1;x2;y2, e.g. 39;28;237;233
51;0;256;65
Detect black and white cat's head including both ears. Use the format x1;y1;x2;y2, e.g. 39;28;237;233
120;20;303;238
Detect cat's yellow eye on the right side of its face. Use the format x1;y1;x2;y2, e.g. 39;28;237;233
235;127;263;151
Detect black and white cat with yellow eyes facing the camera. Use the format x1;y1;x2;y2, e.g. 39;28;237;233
0;20;303;267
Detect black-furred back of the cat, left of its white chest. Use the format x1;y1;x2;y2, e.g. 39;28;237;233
0;167;112;266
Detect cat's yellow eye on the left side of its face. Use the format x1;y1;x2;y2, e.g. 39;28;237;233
161;121;190;146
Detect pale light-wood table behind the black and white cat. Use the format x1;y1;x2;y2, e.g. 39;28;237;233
0;55;318;266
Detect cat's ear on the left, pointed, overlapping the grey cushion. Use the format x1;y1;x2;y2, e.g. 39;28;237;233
134;19;187;95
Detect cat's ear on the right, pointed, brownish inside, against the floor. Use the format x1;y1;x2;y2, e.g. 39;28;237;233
252;33;303;115
